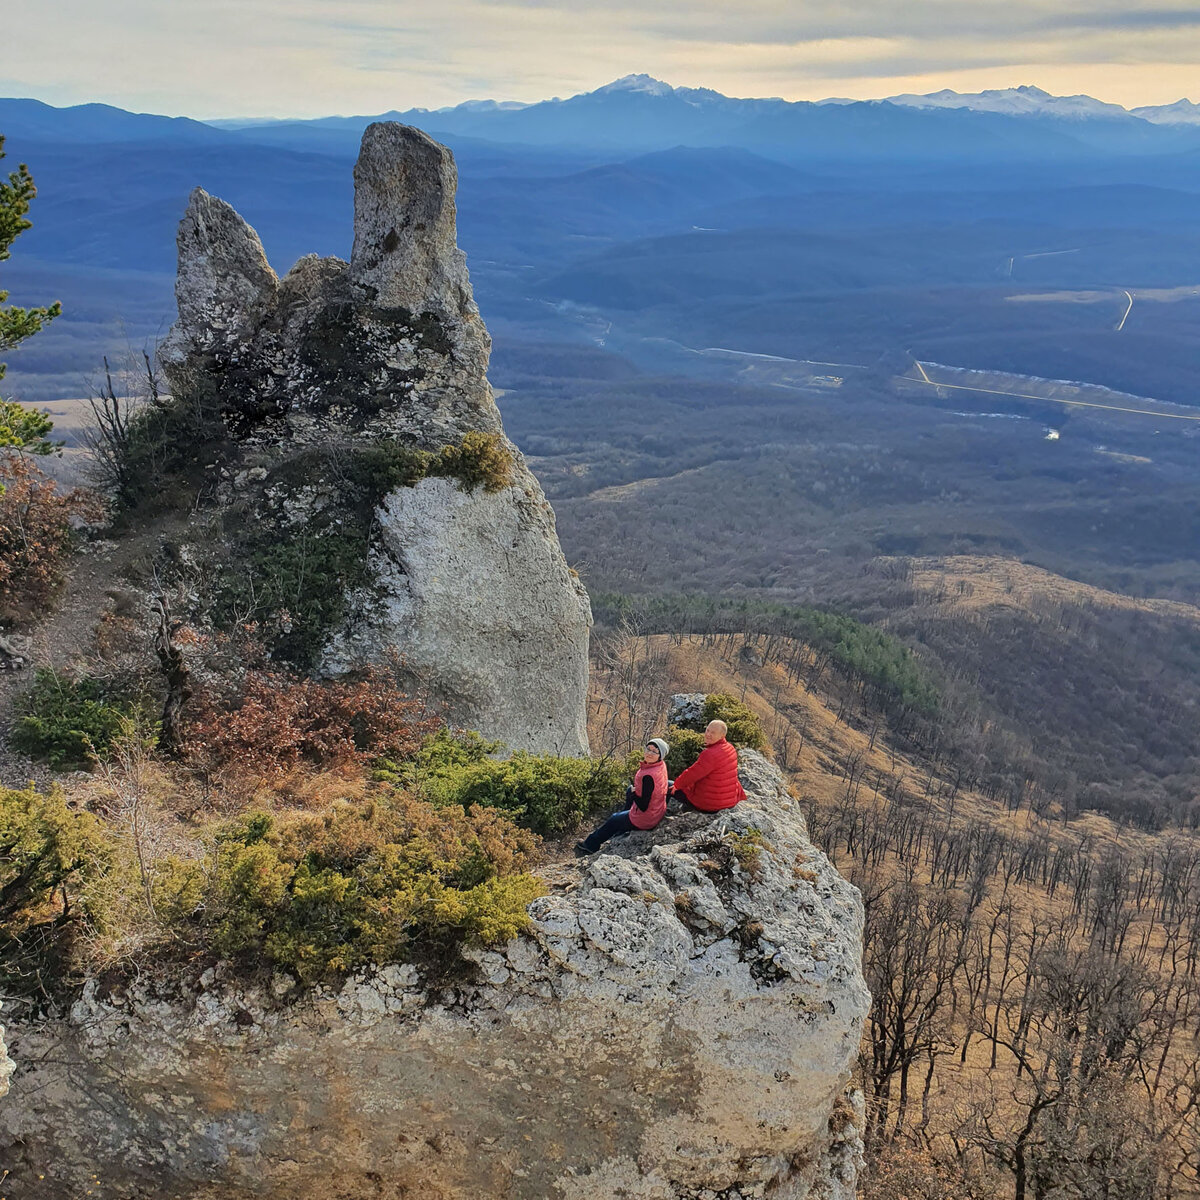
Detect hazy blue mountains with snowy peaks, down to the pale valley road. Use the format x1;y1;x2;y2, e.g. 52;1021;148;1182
0;76;1200;403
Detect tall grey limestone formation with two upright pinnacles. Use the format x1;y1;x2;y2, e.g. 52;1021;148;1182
162;124;592;755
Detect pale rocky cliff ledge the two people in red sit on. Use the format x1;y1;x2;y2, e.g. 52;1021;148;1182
0;752;869;1200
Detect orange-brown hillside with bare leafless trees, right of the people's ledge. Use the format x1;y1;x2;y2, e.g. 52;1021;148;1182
592;631;1200;1200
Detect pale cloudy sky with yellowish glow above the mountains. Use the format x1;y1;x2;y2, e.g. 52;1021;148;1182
7;0;1200;119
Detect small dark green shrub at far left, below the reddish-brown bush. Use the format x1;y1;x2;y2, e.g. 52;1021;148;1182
8;667;152;770
